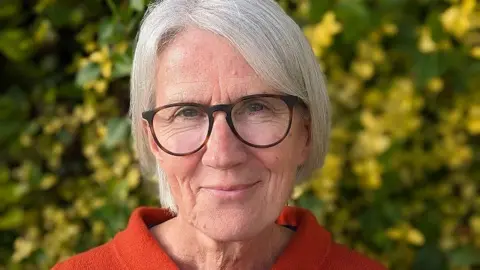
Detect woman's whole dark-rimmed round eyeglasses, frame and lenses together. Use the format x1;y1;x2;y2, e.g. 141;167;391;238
142;94;300;156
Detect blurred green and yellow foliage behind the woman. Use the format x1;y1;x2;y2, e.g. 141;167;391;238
0;0;480;270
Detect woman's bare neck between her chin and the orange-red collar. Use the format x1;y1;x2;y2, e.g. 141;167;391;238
151;217;293;269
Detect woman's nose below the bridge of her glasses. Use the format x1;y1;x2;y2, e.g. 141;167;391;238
202;113;247;170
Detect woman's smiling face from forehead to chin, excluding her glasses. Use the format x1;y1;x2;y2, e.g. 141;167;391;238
147;28;310;241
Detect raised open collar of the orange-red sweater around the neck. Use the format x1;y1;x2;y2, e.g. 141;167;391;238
113;206;332;270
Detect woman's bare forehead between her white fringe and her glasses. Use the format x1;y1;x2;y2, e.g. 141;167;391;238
156;28;269;105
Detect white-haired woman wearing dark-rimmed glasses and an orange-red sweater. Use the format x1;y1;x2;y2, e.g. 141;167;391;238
54;0;384;270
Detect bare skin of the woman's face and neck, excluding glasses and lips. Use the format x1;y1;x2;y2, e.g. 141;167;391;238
145;28;310;269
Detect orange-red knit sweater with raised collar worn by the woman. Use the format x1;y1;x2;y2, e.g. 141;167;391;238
53;207;386;270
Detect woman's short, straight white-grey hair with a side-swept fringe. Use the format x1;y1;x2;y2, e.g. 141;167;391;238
130;0;330;212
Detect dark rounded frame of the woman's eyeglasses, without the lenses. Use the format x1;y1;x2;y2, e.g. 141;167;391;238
142;94;302;156
